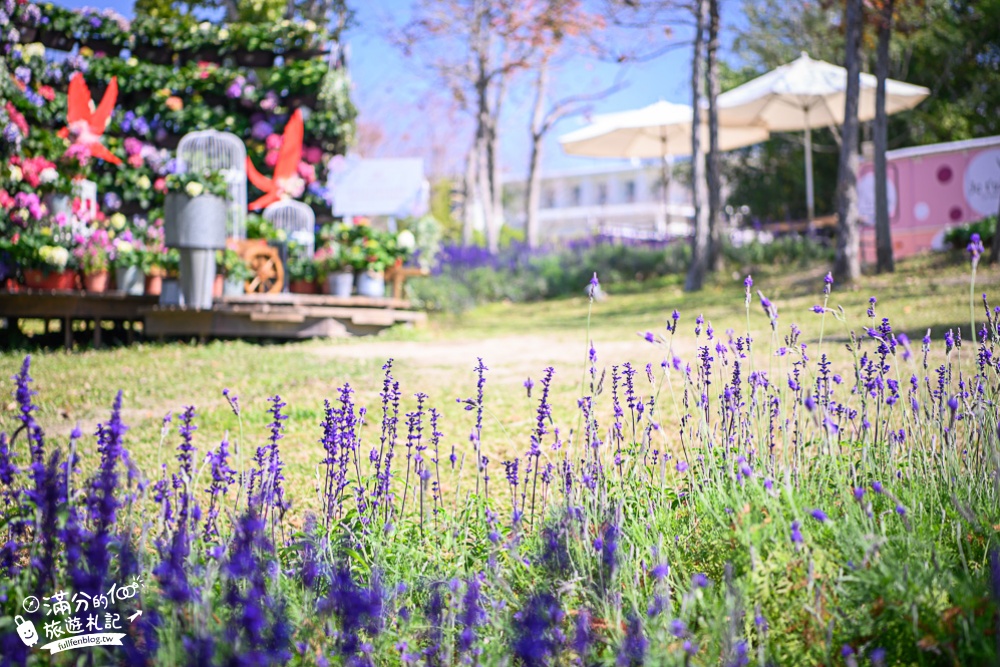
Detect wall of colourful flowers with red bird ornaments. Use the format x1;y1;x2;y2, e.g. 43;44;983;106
0;0;355;280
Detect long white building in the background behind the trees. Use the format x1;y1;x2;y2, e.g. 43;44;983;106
504;164;694;240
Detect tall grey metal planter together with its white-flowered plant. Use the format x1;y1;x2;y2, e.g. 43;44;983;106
163;170;227;309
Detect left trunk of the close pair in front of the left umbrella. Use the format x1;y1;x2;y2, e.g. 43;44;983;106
684;0;709;291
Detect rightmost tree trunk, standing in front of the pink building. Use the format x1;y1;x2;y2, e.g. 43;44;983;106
874;0;896;273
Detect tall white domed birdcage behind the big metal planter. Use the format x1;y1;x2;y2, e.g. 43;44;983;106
177;130;247;239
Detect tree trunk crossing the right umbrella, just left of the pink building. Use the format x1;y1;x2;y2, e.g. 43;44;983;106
833;0;864;283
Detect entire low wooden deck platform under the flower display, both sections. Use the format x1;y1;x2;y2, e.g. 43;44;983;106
0;289;427;349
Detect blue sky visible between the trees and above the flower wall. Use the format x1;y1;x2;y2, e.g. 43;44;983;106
50;0;741;175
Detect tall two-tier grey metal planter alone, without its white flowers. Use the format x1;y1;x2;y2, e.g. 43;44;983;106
163;192;226;309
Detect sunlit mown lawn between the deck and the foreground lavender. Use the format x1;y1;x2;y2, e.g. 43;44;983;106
0;256;1000;505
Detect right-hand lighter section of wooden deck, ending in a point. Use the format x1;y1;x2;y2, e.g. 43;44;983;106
142;294;427;338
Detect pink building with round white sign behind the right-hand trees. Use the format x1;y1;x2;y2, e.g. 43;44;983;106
858;136;1000;262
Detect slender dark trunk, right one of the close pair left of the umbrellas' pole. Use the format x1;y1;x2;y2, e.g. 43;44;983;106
705;0;722;273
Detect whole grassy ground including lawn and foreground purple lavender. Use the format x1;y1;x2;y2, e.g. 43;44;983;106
0;254;1000;665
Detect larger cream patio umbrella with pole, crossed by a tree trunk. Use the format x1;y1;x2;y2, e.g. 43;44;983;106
719;52;931;221
